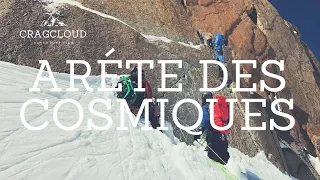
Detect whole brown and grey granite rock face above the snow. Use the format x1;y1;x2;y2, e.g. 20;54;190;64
0;0;320;178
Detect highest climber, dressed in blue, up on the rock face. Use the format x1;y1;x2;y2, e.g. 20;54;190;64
208;33;225;63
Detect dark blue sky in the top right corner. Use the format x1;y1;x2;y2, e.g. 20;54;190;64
269;0;320;60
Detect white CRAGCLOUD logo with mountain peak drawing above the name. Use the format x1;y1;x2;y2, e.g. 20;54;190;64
19;15;87;44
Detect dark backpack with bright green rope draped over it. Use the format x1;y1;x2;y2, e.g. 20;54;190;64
117;76;137;104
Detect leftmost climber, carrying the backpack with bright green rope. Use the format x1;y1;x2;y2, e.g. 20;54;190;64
117;67;160;129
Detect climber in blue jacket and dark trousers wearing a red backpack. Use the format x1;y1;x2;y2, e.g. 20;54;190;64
201;92;230;165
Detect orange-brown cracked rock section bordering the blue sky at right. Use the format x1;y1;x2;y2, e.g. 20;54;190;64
186;0;320;177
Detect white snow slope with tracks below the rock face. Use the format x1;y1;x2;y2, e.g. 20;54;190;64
0;62;291;180
